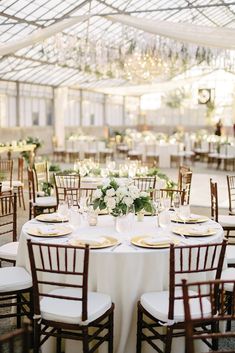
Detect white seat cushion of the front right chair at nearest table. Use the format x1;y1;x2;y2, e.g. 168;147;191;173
140;289;211;324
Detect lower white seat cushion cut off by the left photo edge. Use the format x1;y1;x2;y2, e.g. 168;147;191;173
0;266;32;293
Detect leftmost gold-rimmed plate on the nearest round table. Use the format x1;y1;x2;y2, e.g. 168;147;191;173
27;226;72;238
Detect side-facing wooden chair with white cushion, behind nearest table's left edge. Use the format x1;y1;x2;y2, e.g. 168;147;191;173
28;168;57;219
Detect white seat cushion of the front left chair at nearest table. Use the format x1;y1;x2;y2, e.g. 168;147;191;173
40;288;112;325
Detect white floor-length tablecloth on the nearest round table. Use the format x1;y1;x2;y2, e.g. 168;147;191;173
17;212;223;353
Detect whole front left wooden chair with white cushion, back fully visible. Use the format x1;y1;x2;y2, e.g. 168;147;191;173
28;240;114;353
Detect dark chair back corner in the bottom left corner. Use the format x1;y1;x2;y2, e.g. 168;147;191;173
0;325;31;353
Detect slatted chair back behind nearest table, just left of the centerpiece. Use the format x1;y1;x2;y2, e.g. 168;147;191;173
54;174;80;205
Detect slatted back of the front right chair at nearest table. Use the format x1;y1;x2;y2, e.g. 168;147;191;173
168;240;227;320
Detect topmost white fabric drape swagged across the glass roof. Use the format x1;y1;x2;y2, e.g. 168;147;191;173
0;15;235;56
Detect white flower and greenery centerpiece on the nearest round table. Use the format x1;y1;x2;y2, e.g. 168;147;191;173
93;179;154;217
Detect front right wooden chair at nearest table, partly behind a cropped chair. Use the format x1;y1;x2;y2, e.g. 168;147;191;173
136;240;226;353
